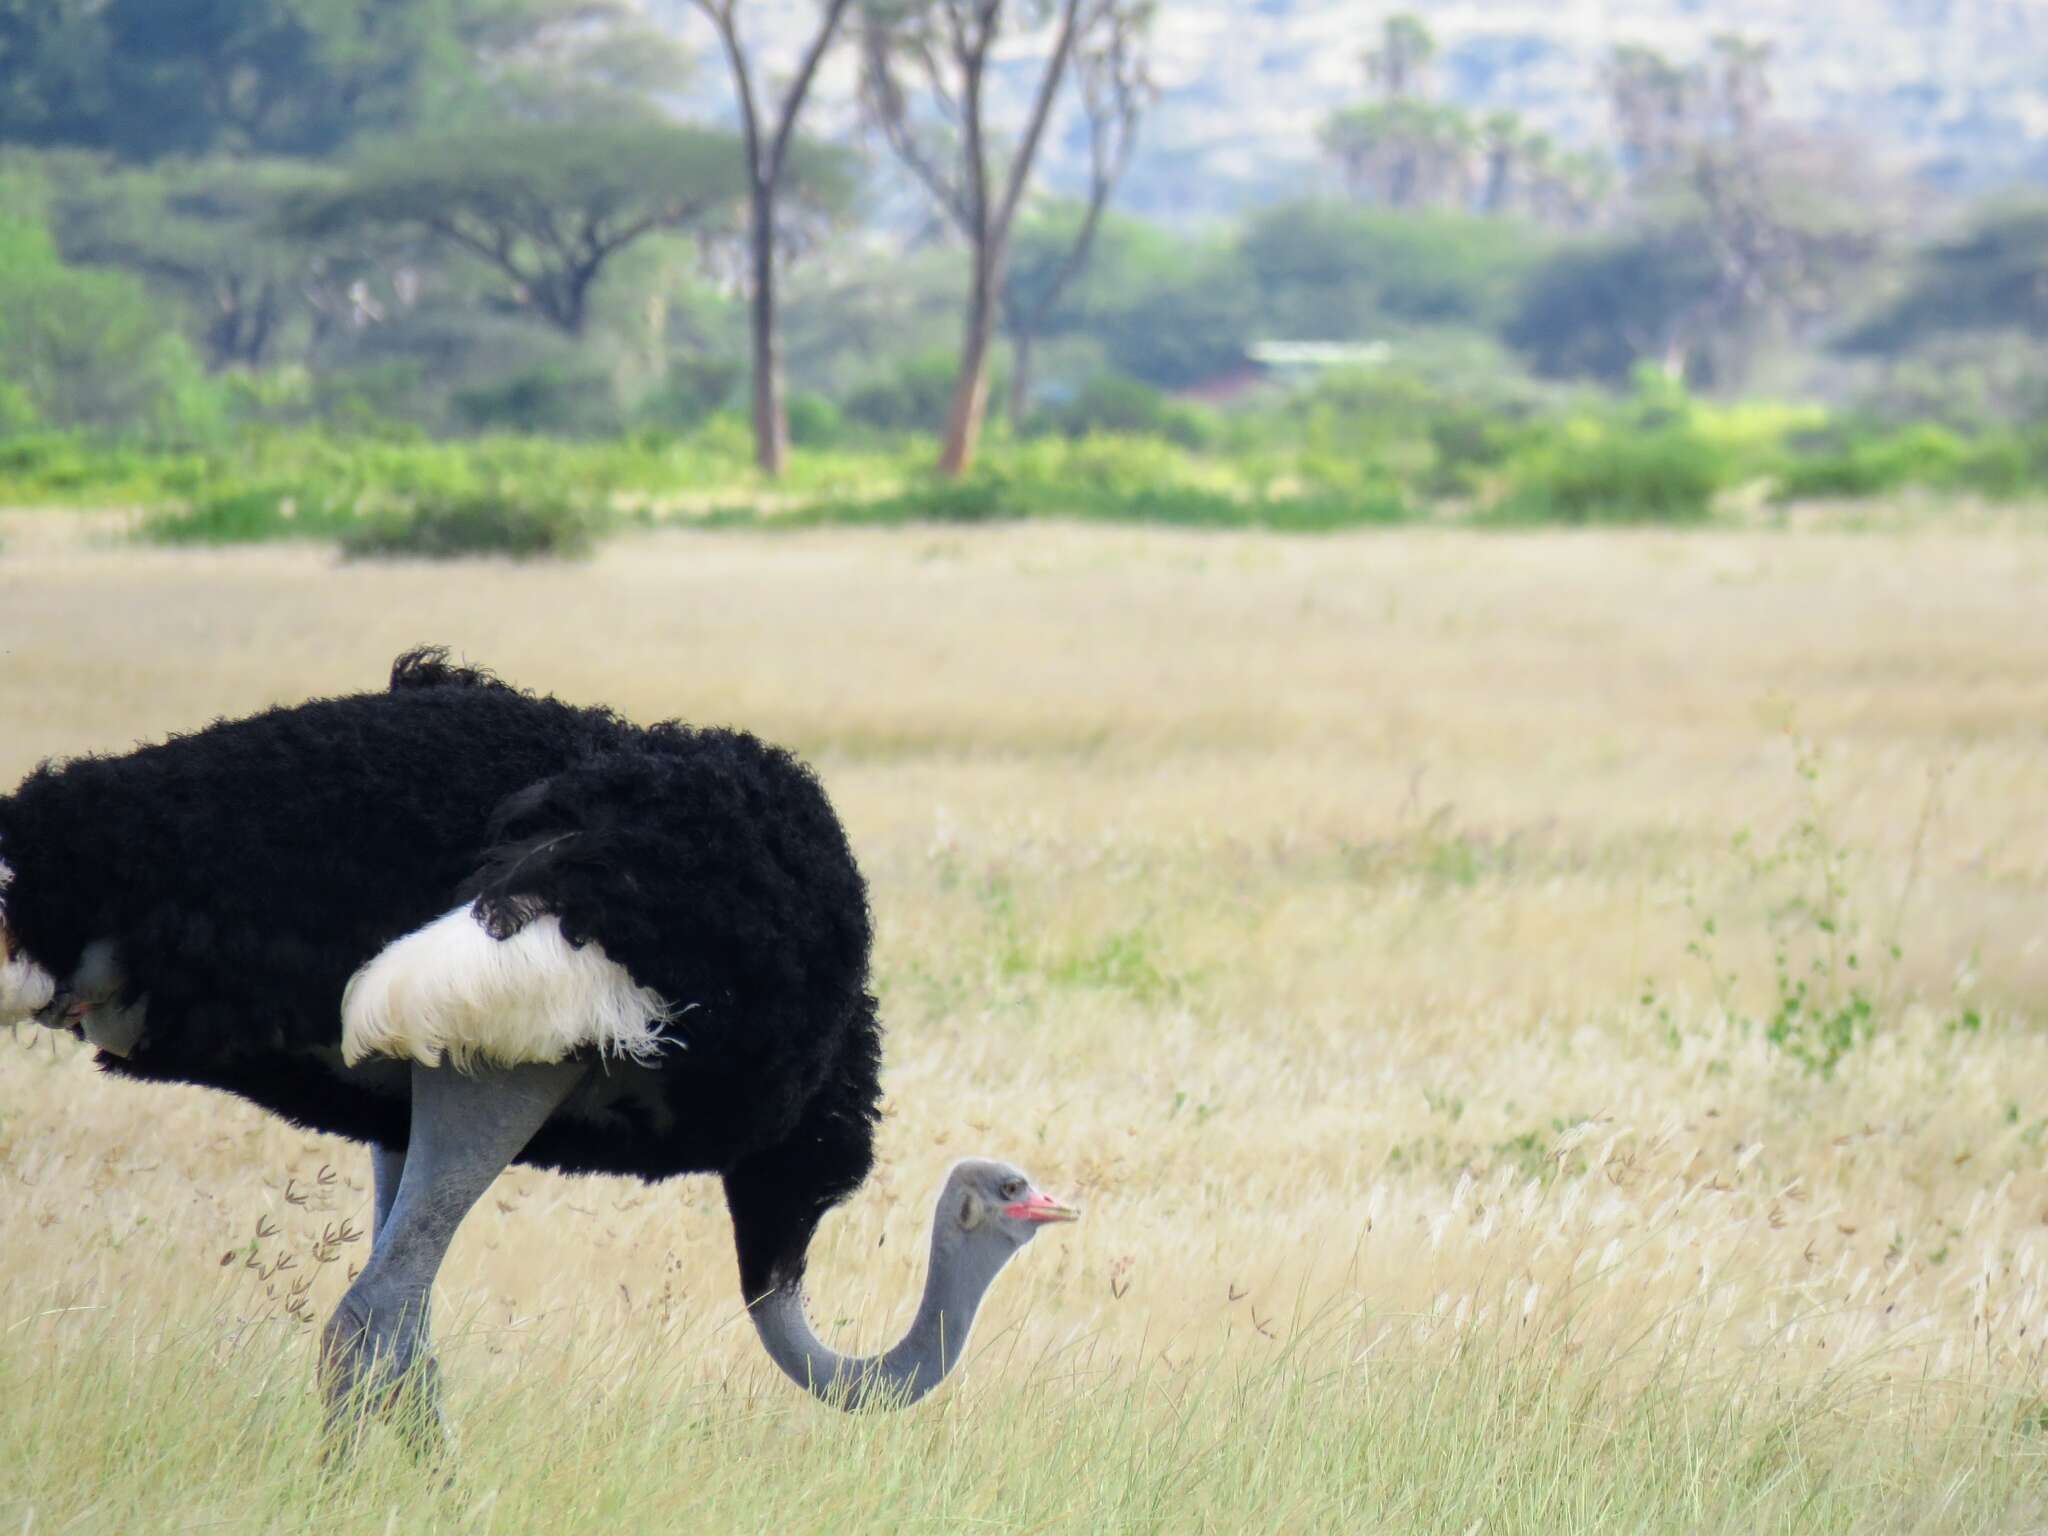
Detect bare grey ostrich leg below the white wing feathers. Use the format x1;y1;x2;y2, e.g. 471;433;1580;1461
319;1061;588;1430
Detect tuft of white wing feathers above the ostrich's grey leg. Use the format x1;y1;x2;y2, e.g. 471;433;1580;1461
342;907;670;1067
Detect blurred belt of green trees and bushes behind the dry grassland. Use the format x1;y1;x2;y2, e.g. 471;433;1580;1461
0;0;2048;553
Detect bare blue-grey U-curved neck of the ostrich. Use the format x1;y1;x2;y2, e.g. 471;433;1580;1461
748;1210;1016;1409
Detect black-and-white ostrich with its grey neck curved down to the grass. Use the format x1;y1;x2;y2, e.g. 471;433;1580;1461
0;649;1079;1423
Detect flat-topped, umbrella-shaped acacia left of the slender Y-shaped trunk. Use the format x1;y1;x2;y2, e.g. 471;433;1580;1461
289;121;745;336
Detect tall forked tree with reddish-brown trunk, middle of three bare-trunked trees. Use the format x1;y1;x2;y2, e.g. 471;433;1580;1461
860;0;1149;477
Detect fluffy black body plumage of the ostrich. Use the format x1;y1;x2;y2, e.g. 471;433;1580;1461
0;651;881;1296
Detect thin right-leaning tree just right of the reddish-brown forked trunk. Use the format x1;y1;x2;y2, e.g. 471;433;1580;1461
1001;0;1155;428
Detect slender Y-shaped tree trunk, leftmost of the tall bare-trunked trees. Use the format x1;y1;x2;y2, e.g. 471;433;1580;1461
692;0;852;475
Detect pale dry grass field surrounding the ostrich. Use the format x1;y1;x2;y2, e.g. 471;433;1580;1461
0;514;2048;1532
